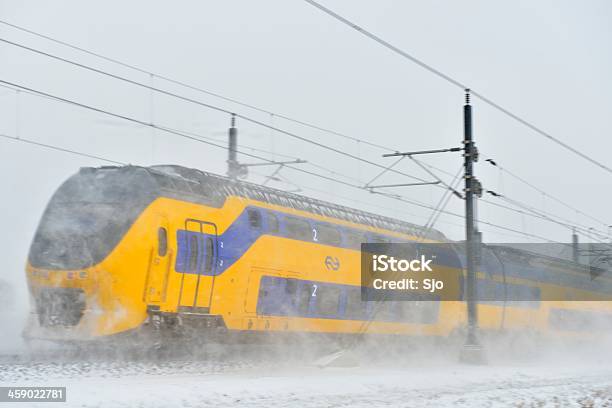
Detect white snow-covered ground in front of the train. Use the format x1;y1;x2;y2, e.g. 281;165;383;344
0;352;612;408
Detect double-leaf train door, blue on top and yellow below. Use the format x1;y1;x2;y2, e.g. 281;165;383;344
177;219;218;313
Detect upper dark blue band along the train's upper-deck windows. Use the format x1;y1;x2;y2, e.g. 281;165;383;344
175;207;612;293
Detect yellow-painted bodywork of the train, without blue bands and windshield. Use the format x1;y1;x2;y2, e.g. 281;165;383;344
26;166;612;339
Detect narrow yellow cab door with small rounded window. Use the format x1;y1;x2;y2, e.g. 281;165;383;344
144;217;173;304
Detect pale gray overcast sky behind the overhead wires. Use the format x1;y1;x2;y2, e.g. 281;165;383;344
0;0;612;290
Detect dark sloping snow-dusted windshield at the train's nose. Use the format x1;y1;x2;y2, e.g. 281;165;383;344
30;167;156;269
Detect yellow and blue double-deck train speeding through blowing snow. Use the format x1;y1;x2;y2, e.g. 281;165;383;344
25;166;612;340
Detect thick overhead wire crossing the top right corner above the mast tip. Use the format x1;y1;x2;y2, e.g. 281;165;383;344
303;0;612;174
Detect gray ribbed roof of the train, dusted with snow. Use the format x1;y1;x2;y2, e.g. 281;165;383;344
89;165;446;241
